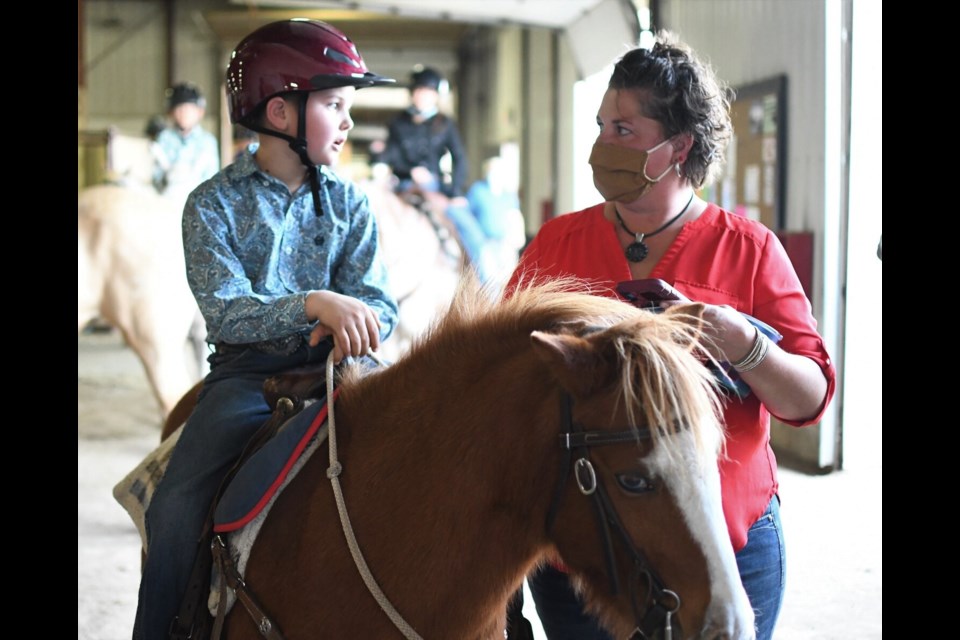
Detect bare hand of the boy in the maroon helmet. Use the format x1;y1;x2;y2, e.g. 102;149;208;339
303;291;380;362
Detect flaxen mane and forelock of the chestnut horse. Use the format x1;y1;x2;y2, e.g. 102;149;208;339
341;273;723;456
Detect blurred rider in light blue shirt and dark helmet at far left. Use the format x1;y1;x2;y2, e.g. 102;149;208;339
151;82;220;204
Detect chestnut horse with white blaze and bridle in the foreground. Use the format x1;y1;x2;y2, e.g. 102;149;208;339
180;278;755;640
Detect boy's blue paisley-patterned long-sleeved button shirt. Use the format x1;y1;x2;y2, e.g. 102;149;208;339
183;152;397;344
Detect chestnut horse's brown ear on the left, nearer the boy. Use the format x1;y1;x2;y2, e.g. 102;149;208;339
530;331;609;396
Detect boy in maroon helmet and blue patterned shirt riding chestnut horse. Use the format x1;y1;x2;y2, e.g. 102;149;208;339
134;20;397;639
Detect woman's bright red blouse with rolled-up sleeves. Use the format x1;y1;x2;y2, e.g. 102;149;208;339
507;204;836;551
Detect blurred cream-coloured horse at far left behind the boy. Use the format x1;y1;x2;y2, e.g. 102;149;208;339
77;184;206;417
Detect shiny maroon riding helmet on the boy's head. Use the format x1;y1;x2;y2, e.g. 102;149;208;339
227;19;395;123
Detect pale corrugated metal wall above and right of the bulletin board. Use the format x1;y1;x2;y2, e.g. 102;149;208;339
657;0;852;467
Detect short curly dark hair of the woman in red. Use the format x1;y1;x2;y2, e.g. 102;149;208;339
607;31;733;188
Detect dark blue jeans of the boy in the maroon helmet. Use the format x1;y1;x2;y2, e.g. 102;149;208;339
133;340;332;640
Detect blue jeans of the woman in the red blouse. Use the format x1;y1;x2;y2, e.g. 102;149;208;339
528;496;786;640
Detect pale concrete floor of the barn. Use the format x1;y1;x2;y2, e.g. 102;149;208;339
77;334;883;640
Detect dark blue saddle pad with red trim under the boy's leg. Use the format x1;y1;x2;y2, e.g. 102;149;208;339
213;391;337;533
